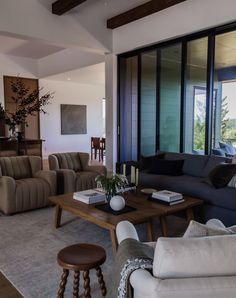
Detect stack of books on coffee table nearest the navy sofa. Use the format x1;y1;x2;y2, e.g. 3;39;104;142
152;190;184;206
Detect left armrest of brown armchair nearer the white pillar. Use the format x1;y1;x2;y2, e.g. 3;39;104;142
56;169;76;194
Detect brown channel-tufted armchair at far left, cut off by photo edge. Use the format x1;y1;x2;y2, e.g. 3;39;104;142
0;156;56;214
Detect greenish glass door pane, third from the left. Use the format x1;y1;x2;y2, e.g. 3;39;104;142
158;44;182;152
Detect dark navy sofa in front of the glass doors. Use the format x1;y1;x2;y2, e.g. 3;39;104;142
139;152;236;226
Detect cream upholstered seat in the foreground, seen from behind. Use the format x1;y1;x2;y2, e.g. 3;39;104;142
116;221;236;298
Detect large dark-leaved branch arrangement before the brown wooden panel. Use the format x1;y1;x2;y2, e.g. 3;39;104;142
0;77;53;137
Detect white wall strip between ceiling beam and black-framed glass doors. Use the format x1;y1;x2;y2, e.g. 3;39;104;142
113;0;236;53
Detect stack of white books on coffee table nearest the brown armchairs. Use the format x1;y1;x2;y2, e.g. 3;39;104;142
73;189;106;204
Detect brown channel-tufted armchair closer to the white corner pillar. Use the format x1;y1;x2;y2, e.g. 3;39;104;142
48;152;106;194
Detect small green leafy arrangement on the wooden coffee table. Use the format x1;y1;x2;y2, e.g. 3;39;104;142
96;174;129;201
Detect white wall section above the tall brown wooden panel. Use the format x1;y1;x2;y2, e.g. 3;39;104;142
0;54;37;104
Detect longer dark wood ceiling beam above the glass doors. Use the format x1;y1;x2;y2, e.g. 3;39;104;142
107;0;186;29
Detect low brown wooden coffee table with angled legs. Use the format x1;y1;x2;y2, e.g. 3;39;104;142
49;191;203;253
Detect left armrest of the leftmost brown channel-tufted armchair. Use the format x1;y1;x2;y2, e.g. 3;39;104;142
0;176;16;214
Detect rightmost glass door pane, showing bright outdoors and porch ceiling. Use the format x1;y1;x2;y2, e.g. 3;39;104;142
212;31;236;148
